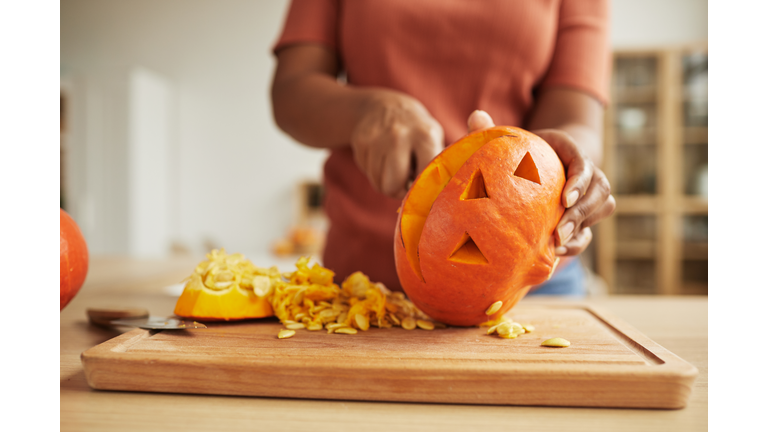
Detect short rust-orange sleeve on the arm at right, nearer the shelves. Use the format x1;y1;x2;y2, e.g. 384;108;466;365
539;0;611;104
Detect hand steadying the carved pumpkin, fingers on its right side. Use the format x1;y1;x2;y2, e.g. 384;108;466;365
467;110;616;256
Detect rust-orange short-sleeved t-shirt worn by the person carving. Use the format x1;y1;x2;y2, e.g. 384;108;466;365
274;0;610;290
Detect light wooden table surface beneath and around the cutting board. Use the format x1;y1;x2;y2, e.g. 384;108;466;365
60;257;708;432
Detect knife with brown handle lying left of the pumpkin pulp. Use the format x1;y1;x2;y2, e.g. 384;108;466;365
86;308;207;330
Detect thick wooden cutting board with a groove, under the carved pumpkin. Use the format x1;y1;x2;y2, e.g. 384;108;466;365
81;304;698;408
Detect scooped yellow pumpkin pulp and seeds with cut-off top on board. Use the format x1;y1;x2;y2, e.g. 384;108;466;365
174;249;533;339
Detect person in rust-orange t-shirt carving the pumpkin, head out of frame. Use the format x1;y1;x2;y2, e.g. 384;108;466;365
272;0;615;295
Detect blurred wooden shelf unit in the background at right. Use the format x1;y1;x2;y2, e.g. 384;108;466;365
595;45;708;295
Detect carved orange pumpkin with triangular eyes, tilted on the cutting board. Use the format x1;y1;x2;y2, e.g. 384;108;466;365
395;126;565;326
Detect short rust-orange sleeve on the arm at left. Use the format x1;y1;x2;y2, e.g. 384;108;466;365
272;0;339;53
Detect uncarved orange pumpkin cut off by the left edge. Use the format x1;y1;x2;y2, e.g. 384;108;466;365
59;209;88;311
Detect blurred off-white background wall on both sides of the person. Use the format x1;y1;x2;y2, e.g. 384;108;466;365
61;0;707;266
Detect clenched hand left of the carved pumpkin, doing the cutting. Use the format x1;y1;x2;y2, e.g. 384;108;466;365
350;89;443;199
